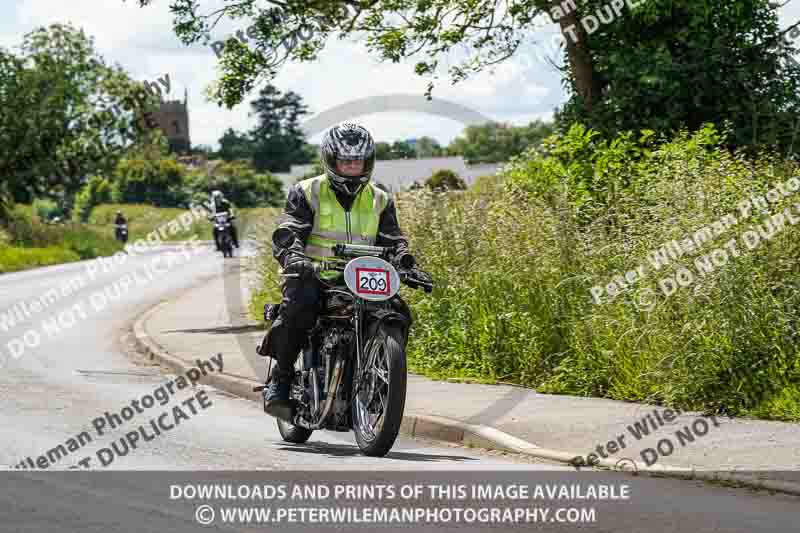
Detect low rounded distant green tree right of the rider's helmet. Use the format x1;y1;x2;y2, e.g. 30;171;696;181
447;120;554;163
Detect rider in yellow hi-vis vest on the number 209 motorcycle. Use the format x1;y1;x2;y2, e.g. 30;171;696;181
261;123;413;421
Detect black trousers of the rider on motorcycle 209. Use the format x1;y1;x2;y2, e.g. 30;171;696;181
269;277;411;371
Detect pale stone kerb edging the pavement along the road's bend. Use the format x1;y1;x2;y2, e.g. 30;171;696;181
132;294;800;496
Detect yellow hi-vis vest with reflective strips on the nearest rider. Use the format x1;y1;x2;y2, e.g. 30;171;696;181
300;174;389;279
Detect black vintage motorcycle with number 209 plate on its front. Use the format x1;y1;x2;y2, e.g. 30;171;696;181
253;229;433;457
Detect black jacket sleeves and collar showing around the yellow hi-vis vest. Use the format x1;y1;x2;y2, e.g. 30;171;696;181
272;184;408;266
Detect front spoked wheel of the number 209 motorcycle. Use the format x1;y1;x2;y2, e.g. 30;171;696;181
353;326;407;457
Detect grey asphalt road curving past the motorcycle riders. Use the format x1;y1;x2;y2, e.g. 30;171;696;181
0;243;800;532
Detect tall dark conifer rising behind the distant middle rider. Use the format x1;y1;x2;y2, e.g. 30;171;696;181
250;85;310;172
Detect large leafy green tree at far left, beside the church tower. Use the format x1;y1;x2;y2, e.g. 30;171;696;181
0;24;164;214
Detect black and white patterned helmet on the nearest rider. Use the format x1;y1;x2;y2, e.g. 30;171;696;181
320;122;375;198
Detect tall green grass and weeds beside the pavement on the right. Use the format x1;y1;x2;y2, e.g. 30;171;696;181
399;123;800;420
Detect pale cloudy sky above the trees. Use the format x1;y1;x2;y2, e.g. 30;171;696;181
0;0;800;148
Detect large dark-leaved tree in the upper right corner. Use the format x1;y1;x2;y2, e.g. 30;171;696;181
558;0;800;150
